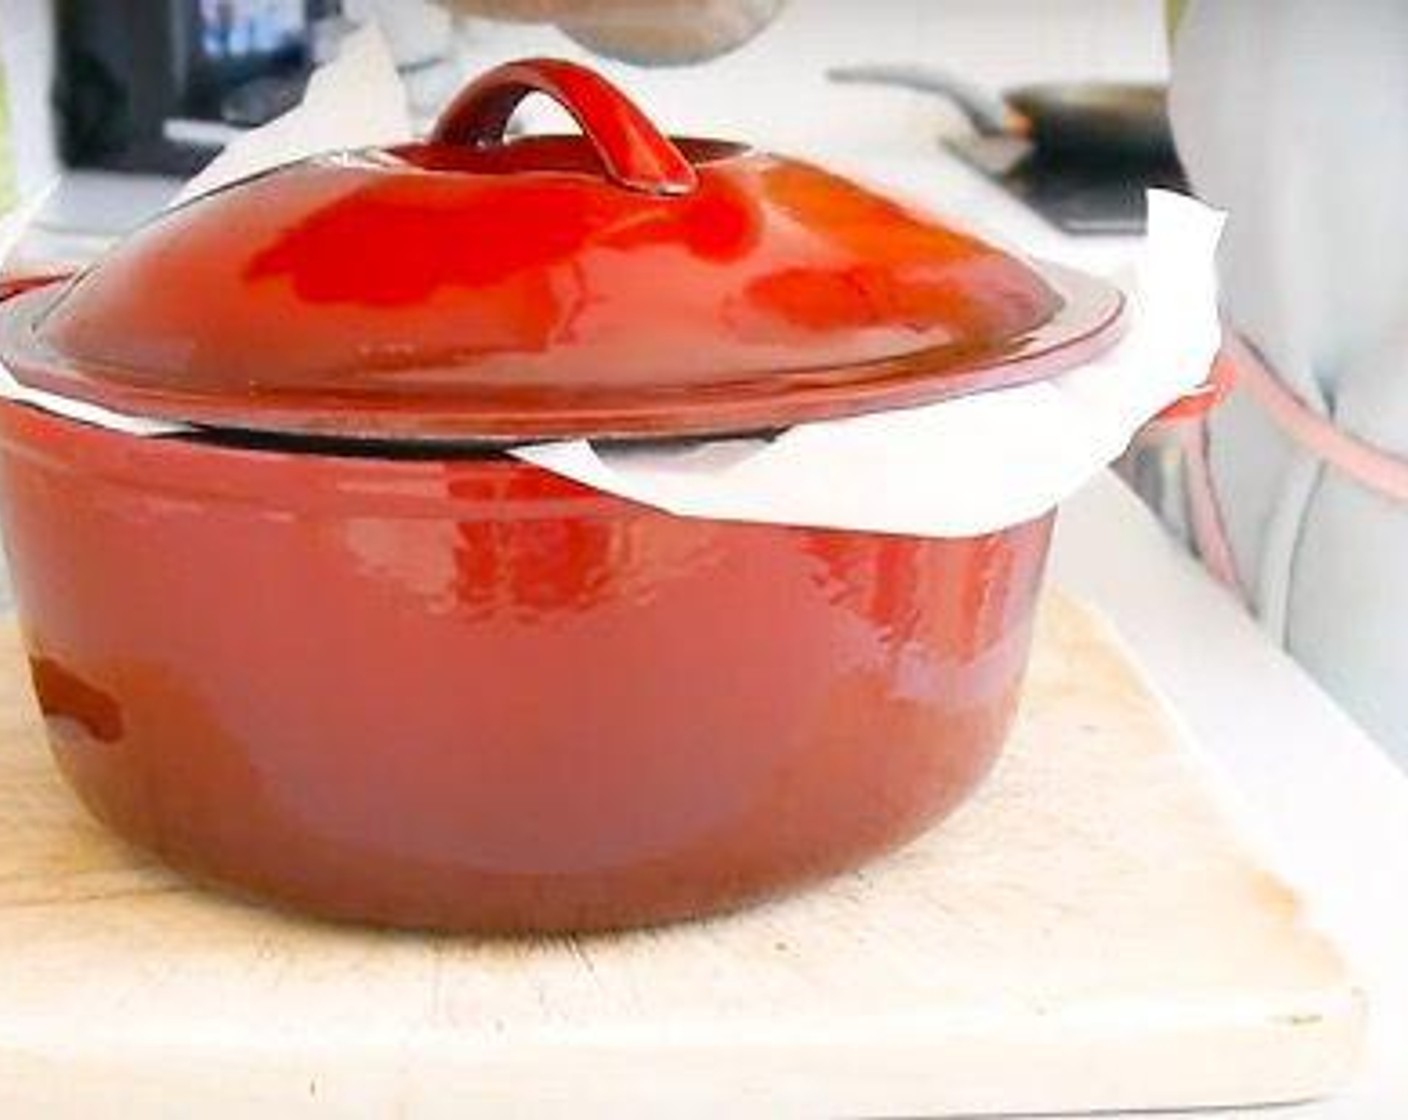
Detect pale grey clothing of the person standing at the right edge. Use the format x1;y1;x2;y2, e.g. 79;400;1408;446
1171;0;1408;764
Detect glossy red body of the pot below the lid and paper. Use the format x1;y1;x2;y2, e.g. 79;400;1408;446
0;404;1049;930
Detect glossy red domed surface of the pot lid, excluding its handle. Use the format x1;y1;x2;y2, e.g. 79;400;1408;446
18;152;1056;434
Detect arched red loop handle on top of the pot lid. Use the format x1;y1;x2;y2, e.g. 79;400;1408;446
431;58;698;194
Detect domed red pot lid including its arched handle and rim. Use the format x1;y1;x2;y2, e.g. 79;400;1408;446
0;61;1121;441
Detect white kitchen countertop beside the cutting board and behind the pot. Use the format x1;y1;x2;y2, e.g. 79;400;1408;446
13;138;1408;1120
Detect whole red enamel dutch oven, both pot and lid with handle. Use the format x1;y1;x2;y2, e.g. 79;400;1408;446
0;61;1199;931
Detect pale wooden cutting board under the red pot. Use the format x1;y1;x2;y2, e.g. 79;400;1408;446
0;596;1362;1117
